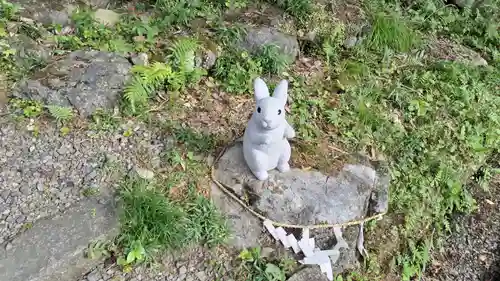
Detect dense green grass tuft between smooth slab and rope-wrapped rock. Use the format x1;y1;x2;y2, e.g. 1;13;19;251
117;178;229;264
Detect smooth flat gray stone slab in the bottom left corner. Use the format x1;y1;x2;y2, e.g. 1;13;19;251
0;197;118;281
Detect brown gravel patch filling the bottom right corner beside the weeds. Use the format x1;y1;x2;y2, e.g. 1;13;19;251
426;159;500;281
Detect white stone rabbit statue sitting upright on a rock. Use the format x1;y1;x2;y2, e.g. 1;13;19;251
243;78;295;181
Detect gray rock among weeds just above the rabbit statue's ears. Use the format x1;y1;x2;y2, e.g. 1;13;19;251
240;27;300;60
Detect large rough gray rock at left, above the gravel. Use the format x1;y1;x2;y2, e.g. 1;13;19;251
13;51;131;117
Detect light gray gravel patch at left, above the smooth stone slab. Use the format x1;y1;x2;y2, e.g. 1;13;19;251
0;116;164;244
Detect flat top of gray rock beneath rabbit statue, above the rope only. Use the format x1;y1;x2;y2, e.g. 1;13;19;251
215;143;389;225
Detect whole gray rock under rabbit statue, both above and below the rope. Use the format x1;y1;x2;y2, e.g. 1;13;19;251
212;143;389;273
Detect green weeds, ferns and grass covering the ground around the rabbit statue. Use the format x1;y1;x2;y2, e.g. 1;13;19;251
0;0;500;280
